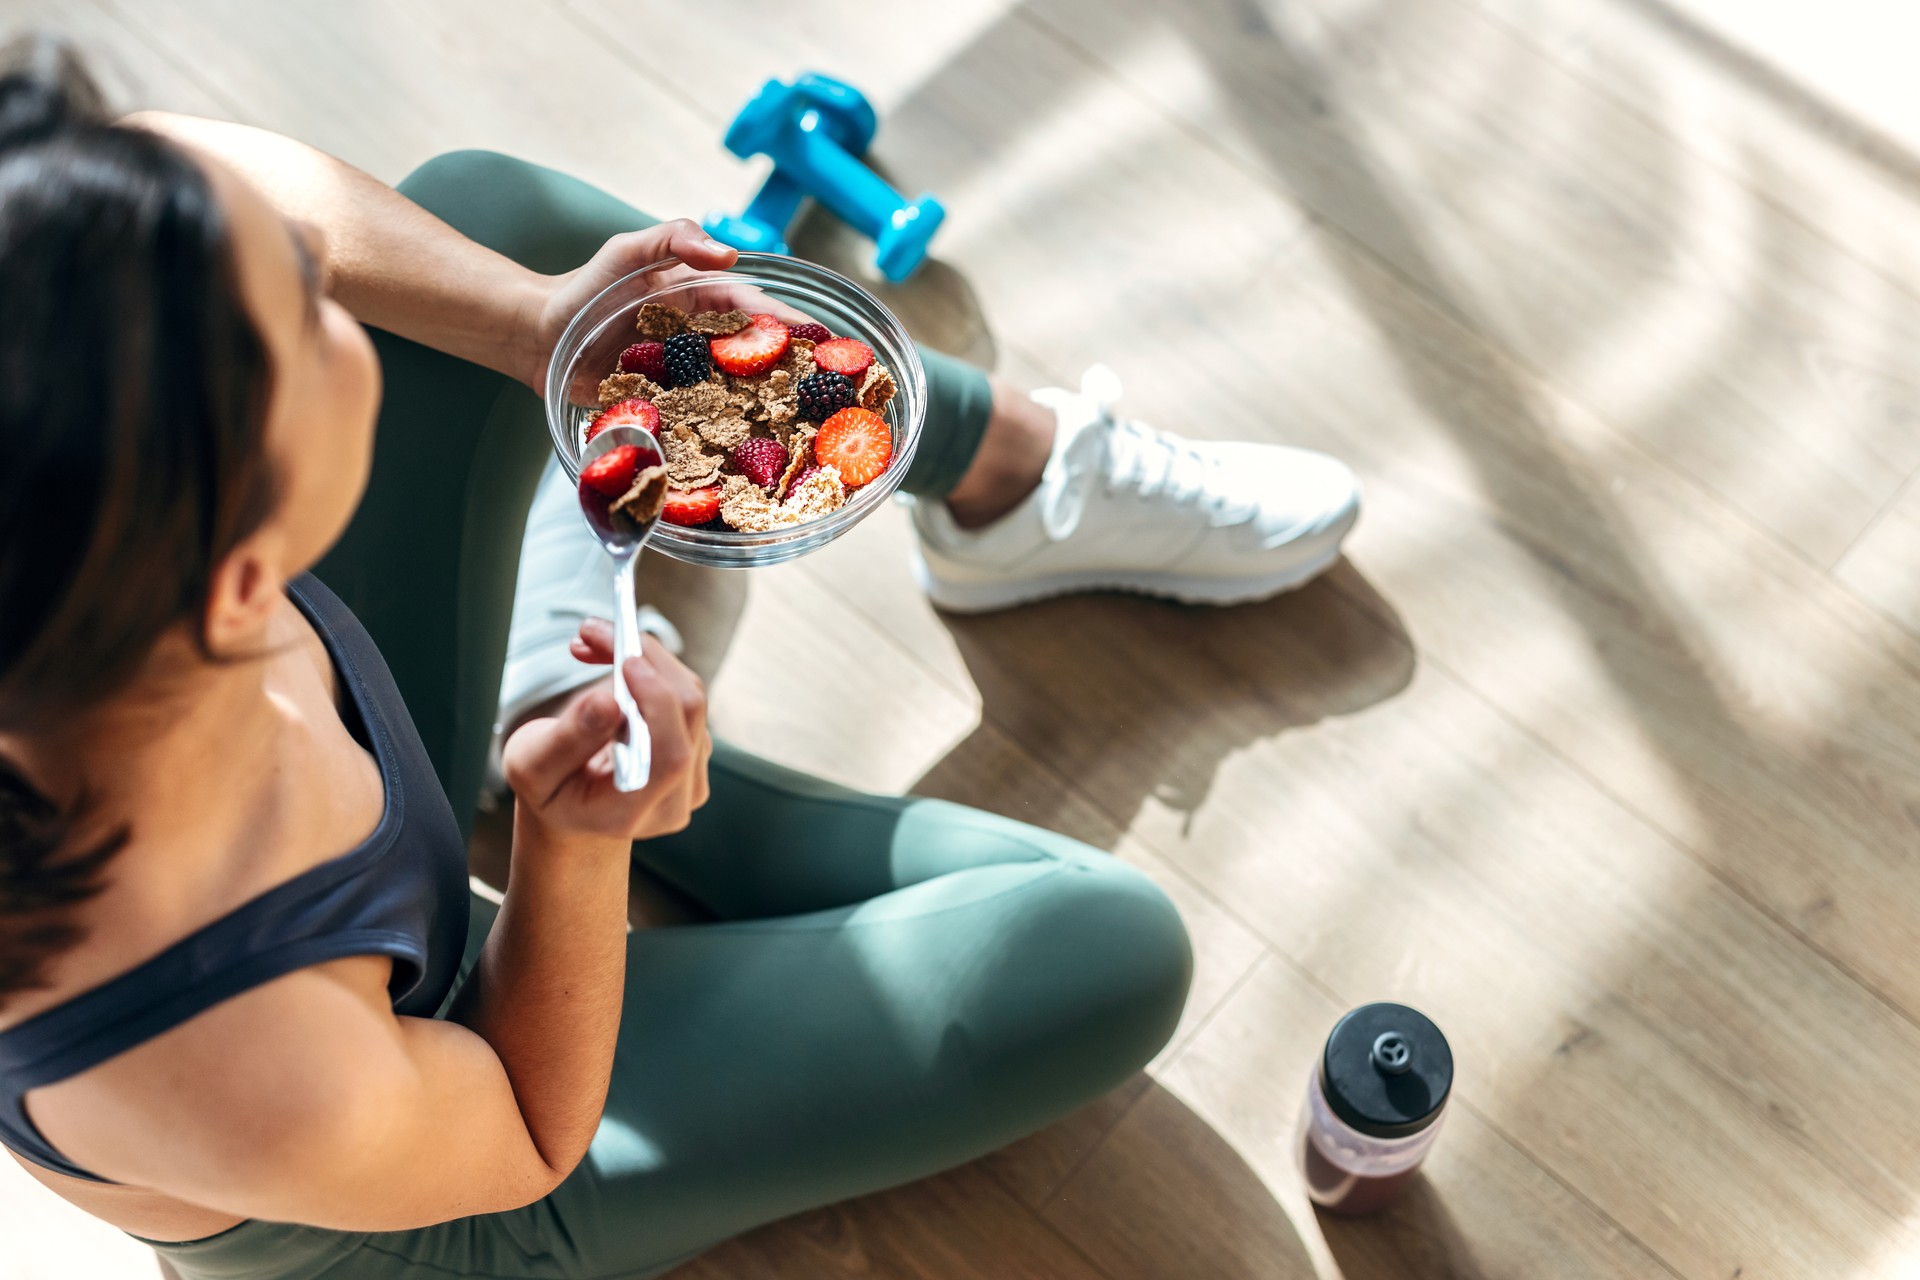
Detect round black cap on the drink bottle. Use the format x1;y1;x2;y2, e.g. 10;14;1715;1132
1321;1004;1453;1138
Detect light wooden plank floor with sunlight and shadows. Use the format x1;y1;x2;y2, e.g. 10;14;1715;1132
0;0;1920;1280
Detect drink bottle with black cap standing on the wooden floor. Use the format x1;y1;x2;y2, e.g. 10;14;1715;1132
1300;1004;1453;1215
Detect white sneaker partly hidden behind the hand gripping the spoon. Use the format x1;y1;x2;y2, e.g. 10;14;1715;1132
486;459;682;791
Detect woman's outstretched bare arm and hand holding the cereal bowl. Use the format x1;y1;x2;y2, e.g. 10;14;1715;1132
127;111;733;390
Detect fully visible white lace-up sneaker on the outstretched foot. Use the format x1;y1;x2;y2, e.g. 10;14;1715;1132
914;365;1359;612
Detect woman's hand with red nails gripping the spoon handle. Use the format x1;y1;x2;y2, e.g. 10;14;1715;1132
503;622;712;841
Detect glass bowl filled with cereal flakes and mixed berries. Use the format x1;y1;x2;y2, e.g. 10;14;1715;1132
545;253;927;568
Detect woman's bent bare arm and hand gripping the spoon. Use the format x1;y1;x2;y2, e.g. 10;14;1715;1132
31;643;710;1230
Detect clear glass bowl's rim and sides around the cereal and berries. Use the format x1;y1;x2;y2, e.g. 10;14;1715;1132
547;253;927;568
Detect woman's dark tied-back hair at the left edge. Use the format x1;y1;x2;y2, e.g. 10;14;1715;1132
0;36;275;1002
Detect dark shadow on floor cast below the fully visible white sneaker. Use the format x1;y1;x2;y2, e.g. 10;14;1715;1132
916;560;1415;846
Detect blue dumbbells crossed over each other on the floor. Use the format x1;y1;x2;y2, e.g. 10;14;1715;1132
703;75;947;282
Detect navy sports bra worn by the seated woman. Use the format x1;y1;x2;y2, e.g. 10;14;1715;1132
0;576;467;1182
